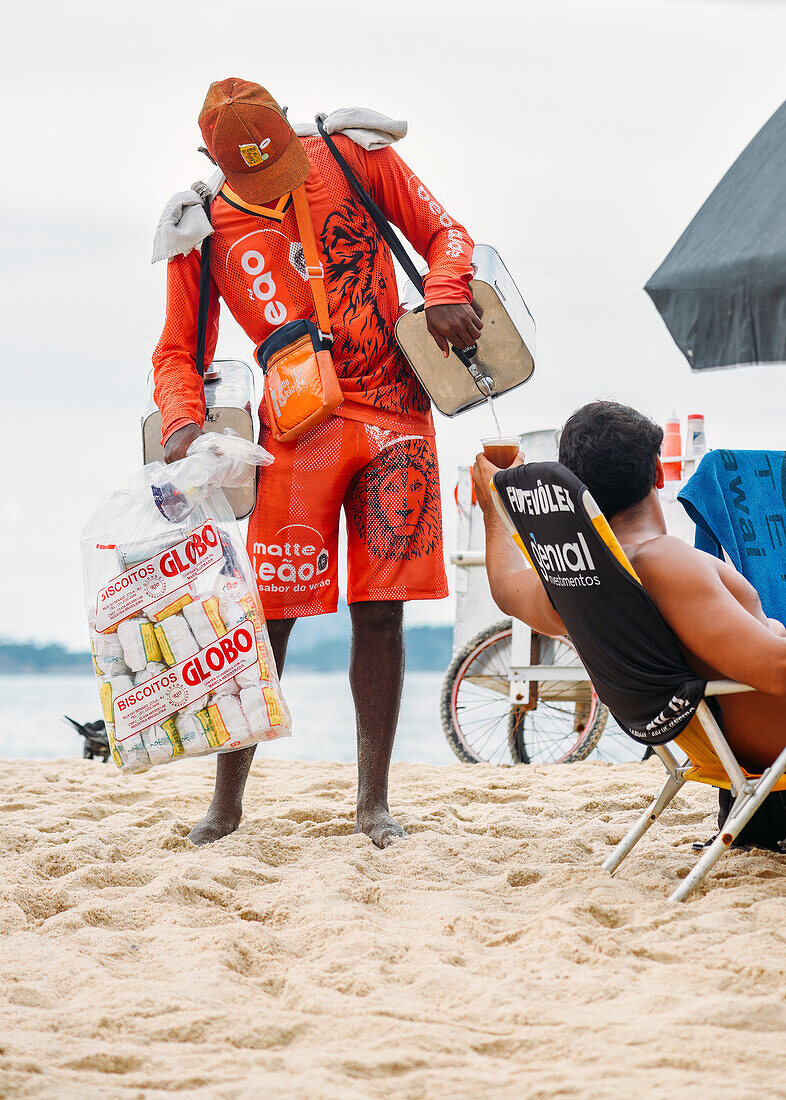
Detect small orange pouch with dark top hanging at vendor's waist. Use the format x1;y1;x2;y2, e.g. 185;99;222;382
256;320;344;443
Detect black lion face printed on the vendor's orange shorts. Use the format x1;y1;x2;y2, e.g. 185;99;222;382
351;439;442;559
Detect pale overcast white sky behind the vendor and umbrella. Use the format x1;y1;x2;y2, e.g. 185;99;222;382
0;0;786;649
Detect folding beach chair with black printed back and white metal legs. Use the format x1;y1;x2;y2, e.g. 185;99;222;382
492;462;786;901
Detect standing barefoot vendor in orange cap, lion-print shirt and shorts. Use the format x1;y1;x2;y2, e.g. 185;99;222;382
153;77;483;848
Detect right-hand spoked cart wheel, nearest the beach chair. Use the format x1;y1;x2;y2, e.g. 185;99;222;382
508;633;609;763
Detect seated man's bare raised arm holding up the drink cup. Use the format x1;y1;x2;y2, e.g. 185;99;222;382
473;453;567;637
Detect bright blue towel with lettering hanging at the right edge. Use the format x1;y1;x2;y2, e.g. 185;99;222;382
678;451;786;624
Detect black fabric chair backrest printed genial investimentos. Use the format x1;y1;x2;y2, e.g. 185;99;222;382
494;462;707;745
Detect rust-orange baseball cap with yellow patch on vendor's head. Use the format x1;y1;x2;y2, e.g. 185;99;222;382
199;76;311;205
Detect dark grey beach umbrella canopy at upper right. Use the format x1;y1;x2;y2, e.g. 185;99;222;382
644;96;786;371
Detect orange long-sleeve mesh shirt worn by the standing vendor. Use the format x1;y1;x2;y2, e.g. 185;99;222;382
153;135;473;441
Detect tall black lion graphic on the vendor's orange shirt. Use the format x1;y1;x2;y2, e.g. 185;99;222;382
322;202;429;413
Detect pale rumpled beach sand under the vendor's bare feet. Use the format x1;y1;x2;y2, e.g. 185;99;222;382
0;760;786;1100
